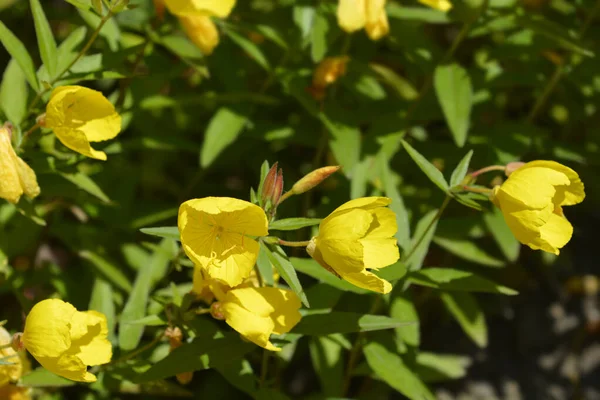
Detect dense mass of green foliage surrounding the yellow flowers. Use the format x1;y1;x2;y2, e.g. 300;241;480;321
0;0;600;399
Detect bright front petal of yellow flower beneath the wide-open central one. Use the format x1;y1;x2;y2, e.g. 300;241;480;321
222;301;281;351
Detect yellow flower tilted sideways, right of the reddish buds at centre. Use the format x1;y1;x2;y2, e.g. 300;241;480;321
306;197;400;293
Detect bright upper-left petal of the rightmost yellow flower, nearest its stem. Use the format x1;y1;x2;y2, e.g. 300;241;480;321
496;167;569;209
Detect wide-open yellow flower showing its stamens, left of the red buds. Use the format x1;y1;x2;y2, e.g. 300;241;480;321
178;197;268;287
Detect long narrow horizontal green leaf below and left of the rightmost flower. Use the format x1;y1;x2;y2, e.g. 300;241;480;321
408;268;518;295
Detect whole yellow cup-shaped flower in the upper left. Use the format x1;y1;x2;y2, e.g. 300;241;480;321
44;86;121;160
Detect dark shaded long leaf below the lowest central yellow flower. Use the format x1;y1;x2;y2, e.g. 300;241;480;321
135;333;256;383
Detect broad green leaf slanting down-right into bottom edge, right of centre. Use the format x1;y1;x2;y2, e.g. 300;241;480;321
363;342;435;400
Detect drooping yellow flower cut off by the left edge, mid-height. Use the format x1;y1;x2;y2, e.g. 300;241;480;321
0;124;40;204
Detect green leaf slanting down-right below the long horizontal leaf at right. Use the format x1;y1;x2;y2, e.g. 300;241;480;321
440;292;488;348
